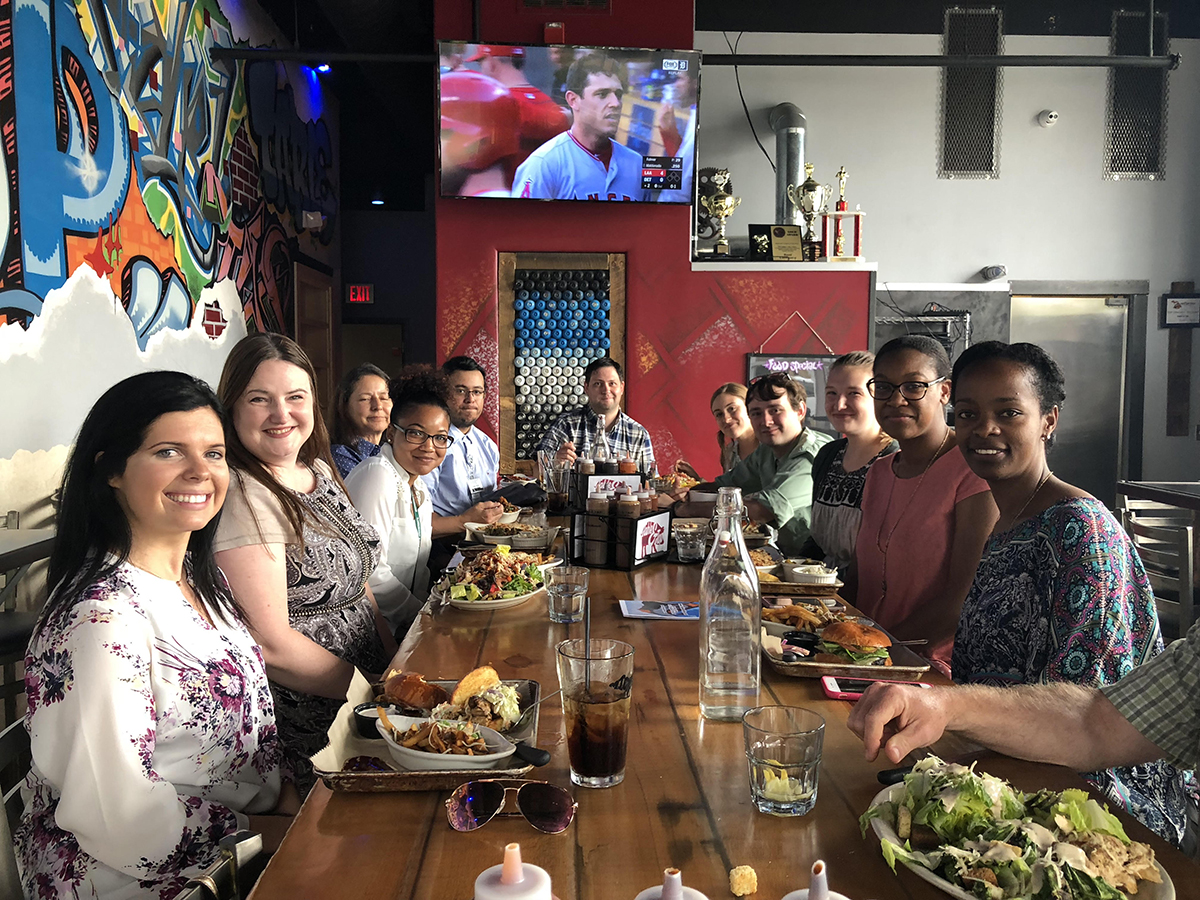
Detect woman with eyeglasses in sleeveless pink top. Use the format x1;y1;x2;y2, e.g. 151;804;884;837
854;335;998;676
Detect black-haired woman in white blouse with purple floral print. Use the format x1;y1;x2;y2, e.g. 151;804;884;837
14;372;298;900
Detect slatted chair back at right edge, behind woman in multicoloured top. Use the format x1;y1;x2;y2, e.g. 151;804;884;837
1126;512;1195;640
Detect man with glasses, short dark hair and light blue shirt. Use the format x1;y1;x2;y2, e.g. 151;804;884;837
422;356;503;538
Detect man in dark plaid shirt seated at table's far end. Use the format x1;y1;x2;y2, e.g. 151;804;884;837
538;356;655;473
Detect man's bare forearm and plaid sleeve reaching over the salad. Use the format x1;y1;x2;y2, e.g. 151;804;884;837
847;622;1200;787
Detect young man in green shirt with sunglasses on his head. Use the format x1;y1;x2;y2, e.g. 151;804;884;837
677;372;832;556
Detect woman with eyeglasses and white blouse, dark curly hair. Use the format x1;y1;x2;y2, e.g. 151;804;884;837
346;368;455;638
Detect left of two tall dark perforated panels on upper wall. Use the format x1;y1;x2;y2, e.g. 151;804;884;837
937;6;1004;178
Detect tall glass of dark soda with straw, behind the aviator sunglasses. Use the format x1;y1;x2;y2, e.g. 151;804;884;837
556;638;634;787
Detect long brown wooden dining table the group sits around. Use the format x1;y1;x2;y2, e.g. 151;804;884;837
251;564;1200;900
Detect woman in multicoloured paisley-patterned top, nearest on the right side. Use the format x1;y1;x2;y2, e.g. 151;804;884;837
953;341;1187;844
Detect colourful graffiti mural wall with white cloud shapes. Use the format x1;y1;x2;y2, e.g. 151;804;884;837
0;0;338;535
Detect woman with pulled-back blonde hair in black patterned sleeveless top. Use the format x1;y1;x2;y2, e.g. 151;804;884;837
800;350;899;602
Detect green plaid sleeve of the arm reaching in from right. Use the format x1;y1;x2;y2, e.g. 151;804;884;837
1100;623;1200;769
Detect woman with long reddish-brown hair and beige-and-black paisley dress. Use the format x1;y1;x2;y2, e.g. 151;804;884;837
215;334;396;794
